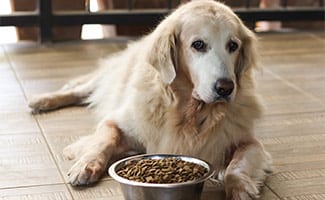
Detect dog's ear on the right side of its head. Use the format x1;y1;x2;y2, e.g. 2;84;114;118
235;25;258;77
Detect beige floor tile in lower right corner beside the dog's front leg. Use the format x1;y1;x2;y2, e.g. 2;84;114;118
258;112;325;199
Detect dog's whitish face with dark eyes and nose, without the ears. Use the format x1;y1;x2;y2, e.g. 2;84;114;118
180;17;242;103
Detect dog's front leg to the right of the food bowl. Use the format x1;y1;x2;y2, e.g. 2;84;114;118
224;139;272;200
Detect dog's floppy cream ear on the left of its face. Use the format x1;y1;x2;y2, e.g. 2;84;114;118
148;27;177;84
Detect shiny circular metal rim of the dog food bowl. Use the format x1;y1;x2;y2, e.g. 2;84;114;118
108;154;214;188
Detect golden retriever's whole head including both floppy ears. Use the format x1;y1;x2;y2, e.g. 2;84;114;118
149;0;256;103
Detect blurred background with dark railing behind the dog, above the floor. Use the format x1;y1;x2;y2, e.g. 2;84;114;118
0;0;324;43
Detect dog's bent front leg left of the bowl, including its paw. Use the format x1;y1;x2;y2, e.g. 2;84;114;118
64;121;128;186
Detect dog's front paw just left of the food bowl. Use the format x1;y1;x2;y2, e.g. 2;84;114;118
68;158;105;186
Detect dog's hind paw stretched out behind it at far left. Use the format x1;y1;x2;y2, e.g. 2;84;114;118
28;95;57;114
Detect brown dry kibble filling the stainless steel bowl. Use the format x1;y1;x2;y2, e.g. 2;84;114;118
117;157;207;183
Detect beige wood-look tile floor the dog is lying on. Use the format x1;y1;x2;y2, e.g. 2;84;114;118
0;32;325;200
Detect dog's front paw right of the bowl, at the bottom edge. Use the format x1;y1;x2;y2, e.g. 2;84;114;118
225;174;259;200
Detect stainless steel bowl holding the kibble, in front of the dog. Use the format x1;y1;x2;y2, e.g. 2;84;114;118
108;154;213;200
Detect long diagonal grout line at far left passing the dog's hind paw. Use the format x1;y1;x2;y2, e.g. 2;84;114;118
1;45;74;199
